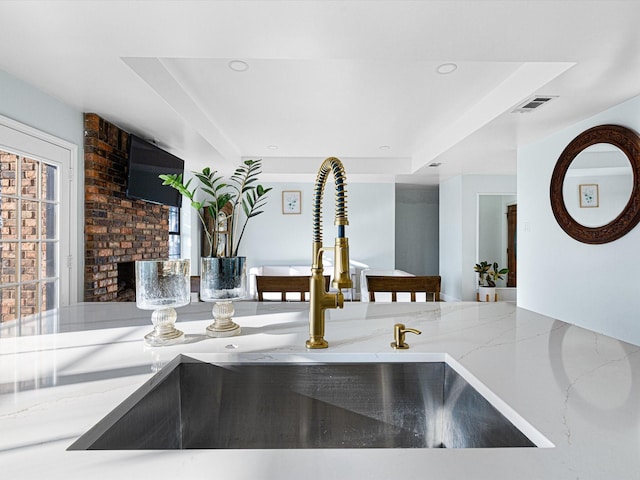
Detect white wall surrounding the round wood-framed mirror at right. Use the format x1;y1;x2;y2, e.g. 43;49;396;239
518;97;640;345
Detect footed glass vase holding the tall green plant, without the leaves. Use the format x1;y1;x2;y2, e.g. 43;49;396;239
200;257;247;338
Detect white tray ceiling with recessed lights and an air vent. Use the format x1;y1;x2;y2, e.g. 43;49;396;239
0;0;640;184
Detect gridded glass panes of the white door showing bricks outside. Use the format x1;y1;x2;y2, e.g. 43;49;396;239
0;150;60;335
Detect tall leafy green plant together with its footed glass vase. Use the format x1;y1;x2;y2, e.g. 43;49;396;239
160;160;271;337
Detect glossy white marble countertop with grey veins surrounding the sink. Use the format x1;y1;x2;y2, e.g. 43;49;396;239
0;302;640;480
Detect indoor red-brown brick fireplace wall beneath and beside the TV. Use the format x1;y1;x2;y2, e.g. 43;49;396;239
84;113;169;302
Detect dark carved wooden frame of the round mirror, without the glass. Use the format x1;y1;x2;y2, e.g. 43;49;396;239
550;125;640;244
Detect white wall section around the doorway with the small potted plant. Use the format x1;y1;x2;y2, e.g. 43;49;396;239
440;175;520;301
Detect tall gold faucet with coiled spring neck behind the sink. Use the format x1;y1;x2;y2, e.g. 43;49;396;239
306;157;353;348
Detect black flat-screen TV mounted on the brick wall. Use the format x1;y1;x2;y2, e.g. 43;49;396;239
127;135;184;207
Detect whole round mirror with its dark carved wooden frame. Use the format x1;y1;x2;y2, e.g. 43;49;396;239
551;125;640;244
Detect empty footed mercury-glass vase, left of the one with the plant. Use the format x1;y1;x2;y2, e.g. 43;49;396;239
136;260;191;347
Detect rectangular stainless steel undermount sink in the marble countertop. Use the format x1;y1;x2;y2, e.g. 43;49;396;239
69;356;548;450
